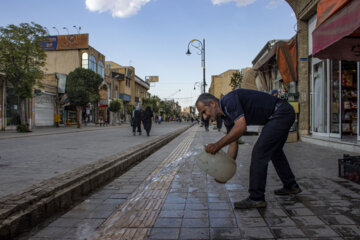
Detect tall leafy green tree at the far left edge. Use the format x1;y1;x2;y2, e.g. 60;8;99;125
0;22;47;130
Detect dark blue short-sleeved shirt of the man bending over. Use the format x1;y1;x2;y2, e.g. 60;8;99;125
219;89;278;132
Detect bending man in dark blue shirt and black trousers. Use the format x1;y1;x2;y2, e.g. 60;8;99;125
196;89;301;209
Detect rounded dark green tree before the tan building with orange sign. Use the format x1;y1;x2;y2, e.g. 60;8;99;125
66;68;103;128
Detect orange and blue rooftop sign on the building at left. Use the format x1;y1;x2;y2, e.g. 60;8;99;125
41;34;89;51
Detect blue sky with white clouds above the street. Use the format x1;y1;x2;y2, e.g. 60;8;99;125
0;0;296;108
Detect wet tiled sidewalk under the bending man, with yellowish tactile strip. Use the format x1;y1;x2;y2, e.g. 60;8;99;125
20;125;360;240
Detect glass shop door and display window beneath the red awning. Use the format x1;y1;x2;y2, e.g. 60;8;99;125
311;59;359;139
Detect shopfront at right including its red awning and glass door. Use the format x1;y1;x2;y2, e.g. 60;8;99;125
308;0;360;141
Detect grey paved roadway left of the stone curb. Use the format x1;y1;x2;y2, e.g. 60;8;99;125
0;123;191;197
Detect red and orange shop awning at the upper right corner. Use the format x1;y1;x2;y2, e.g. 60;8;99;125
312;0;360;61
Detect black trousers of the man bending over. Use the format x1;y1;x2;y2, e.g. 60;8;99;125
249;102;296;200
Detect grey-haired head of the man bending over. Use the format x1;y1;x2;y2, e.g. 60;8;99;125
195;93;222;121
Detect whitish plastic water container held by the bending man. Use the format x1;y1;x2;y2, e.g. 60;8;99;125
196;150;236;183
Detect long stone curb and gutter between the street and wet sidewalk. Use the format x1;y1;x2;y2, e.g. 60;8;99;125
0;125;192;240
